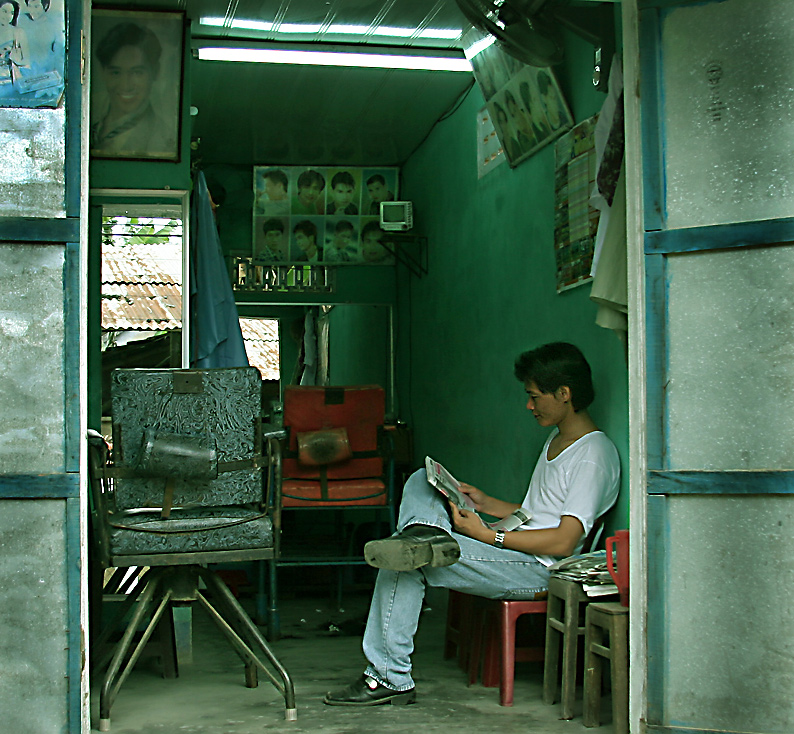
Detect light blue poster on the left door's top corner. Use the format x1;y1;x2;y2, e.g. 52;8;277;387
0;0;66;107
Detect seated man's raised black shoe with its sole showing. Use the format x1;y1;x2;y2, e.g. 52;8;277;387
364;525;460;571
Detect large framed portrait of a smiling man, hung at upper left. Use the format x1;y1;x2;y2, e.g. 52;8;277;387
90;8;185;162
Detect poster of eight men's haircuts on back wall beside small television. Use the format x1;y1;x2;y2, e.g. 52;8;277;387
253;166;399;265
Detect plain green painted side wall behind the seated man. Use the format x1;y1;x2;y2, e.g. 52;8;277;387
397;33;628;529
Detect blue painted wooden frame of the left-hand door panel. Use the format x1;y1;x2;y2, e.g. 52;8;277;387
0;0;87;734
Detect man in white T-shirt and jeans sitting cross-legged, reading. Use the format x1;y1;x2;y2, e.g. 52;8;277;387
324;342;620;706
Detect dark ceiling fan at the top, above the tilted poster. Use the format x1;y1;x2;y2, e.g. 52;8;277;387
456;0;614;66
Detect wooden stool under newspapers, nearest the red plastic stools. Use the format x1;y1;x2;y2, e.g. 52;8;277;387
543;576;590;719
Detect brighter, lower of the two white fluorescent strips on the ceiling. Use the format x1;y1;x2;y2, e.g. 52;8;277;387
198;46;471;73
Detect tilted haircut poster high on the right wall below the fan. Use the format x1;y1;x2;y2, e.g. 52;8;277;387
469;31;573;167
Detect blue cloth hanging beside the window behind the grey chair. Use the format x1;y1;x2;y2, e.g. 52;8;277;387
190;173;248;369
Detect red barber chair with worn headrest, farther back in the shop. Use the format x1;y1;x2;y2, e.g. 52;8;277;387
268;386;395;639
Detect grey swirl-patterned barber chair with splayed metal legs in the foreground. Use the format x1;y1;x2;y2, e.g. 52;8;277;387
89;367;297;731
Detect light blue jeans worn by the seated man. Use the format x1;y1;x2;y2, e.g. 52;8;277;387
364;469;549;691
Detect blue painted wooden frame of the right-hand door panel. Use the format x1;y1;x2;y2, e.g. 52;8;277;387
637;0;794;733
